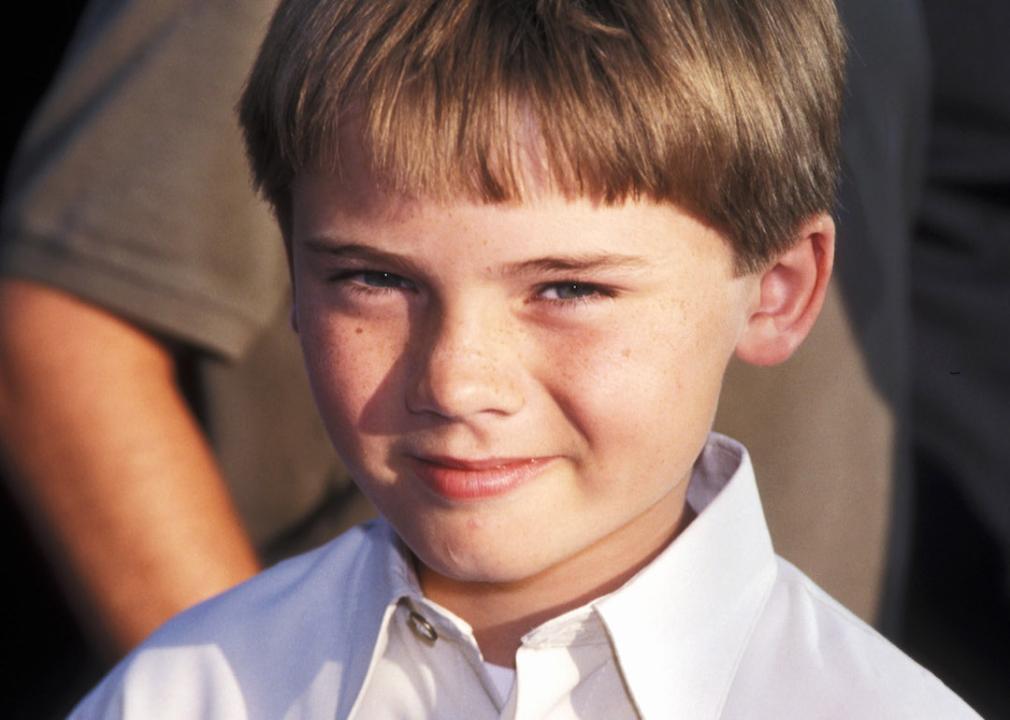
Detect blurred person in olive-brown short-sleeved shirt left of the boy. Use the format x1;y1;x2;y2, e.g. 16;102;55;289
0;0;368;717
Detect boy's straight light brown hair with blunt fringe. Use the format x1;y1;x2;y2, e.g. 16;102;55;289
239;0;844;272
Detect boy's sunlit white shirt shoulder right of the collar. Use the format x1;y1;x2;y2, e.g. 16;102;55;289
723;557;979;720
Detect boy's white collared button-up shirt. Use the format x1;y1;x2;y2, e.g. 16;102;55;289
73;434;978;720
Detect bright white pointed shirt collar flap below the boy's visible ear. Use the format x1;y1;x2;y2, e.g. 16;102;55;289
594;433;776;718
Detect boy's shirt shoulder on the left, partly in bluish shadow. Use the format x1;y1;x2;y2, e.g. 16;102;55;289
72;520;394;719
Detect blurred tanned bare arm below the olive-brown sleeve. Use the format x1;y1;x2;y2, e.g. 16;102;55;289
0;280;259;654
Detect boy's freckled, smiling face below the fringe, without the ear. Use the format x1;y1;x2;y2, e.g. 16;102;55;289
292;166;754;583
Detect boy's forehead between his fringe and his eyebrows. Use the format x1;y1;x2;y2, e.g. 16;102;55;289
294;168;733;279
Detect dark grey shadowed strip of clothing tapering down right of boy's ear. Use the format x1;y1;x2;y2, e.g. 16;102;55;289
834;0;929;639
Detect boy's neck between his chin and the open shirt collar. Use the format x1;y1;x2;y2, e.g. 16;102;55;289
417;483;695;667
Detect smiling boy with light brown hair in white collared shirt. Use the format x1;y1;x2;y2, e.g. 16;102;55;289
71;0;974;719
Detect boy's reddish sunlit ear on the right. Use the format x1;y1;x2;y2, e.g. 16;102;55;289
736;213;834;366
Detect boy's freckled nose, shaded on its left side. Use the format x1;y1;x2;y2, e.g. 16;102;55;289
407;304;524;420
